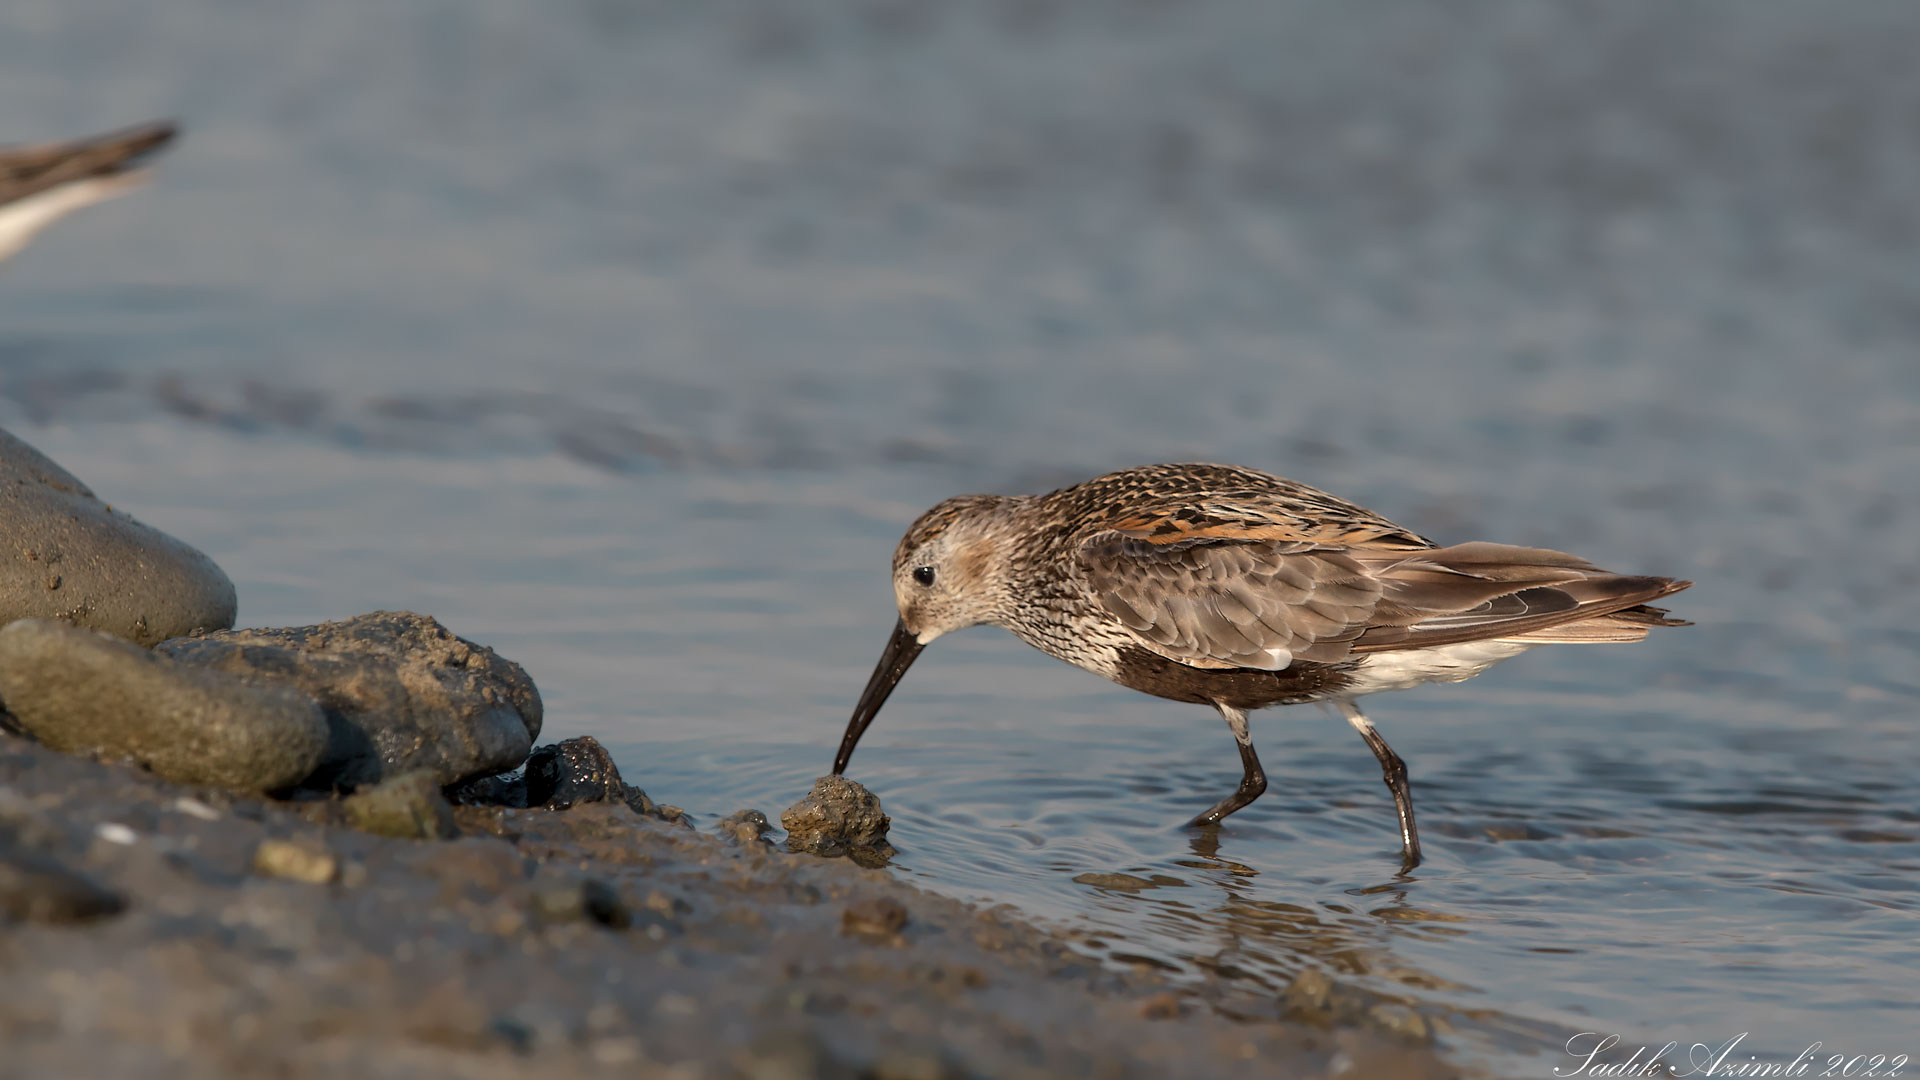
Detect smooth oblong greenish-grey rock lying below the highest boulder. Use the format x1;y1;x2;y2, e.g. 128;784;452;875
0;619;326;792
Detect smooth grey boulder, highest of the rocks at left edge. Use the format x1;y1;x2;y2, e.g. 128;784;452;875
0;430;234;646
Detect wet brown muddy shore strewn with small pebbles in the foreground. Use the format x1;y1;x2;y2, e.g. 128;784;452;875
0;726;1452;1078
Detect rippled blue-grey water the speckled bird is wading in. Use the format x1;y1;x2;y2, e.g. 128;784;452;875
0;0;1920;1076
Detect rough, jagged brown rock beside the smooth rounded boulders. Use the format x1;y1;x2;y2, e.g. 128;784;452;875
157;611;541;788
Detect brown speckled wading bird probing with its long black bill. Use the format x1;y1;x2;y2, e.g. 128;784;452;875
833;465;1692;869
